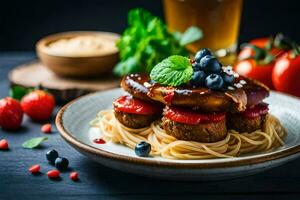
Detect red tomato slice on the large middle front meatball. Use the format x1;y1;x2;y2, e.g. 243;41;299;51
164;107;225;125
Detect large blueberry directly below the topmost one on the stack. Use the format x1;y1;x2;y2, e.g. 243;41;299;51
200;55;221;74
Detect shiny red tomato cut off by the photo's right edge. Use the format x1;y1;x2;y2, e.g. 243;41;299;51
272;53;300;97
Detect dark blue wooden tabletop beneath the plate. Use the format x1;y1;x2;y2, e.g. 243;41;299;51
0;52;300;200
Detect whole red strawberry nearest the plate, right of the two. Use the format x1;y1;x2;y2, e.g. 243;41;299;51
21;90;55;121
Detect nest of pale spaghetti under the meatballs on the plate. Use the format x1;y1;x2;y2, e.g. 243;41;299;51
91;110;286;159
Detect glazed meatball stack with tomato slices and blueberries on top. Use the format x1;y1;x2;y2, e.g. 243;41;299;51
114;49;269;142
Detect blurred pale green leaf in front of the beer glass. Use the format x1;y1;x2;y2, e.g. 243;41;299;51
179;26;203;46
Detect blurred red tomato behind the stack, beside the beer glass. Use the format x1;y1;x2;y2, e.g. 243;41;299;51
234;59;274;89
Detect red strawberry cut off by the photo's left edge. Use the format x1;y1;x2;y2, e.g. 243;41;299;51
0;97;23;131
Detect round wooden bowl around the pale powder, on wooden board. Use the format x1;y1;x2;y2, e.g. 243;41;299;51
36;31;120;78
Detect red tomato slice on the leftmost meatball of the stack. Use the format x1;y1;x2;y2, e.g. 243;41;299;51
113;96;162;115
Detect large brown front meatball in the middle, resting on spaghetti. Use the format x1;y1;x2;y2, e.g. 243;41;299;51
162;117;227;143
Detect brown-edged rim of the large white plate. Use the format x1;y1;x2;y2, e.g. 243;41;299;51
55;88;300;169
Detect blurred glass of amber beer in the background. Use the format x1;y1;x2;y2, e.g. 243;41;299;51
164;0;243;64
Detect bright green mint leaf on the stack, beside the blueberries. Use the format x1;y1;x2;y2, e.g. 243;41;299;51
150;55;193;86
